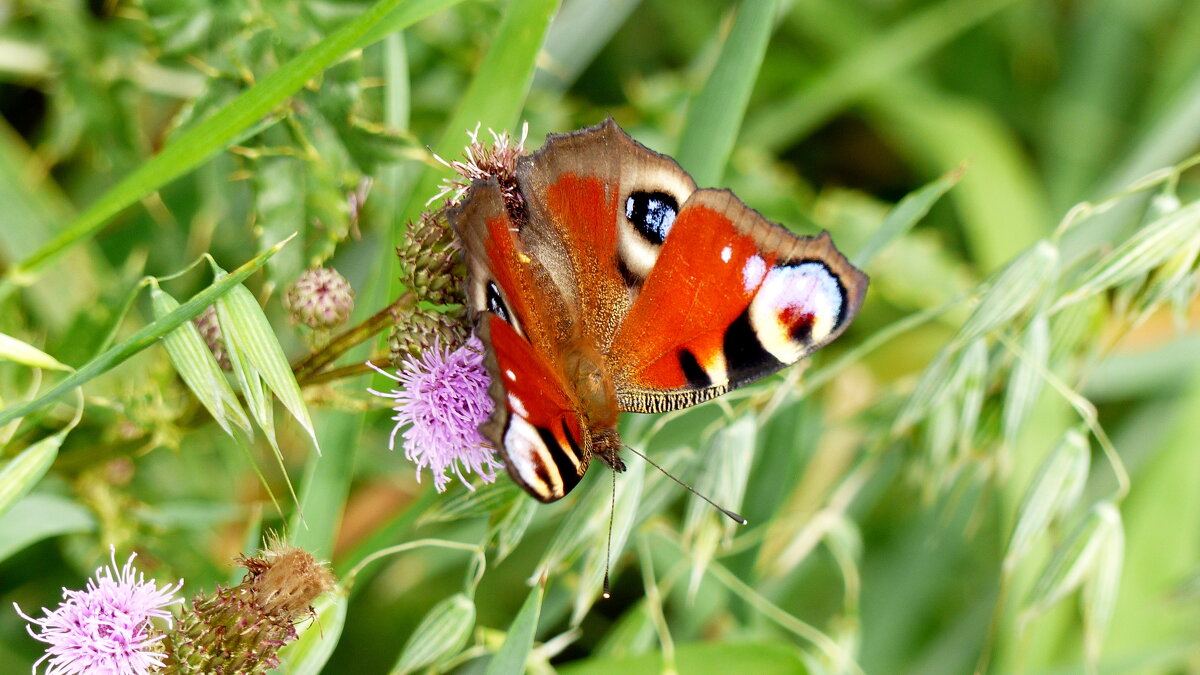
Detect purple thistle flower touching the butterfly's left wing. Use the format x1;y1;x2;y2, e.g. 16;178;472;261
367;335;504;492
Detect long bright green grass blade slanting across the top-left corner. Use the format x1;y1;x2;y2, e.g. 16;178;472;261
0;0;458;299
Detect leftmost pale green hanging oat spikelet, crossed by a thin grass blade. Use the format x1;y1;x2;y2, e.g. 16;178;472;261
150;286;254;436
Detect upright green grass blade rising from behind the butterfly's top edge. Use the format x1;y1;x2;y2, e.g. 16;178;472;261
676;0;779;187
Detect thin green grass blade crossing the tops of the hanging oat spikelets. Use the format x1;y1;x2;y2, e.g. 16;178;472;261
0;240;288;425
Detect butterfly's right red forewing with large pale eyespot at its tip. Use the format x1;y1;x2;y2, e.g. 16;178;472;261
610;190;866;412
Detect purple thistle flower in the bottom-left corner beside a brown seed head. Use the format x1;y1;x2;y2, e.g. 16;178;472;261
13;549;184;675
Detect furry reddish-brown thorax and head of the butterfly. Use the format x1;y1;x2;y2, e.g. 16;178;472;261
562;339;625;471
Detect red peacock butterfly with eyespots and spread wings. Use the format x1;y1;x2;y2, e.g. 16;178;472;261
448;118;868;502
